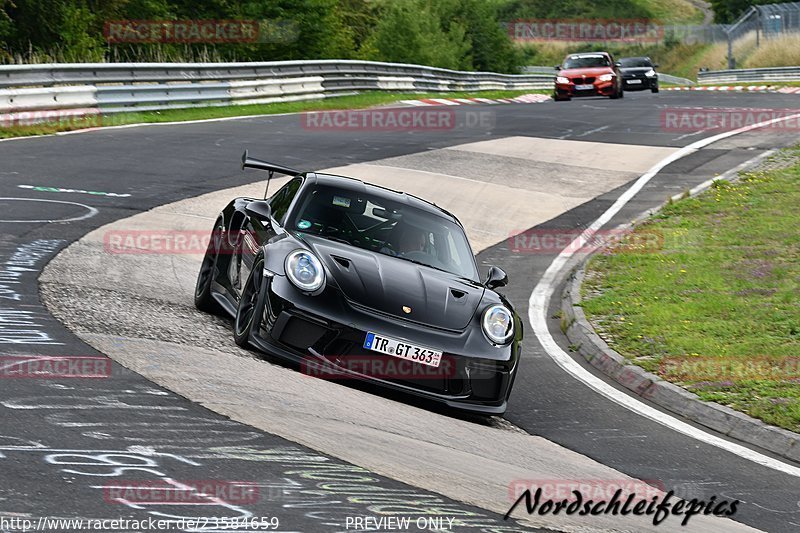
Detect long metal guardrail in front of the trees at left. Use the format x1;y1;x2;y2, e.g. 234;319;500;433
0;60;553;117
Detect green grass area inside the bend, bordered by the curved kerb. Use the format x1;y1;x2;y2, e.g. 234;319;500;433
582;148;800;431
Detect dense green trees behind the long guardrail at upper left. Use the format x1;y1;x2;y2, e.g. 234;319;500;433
0;0;521;72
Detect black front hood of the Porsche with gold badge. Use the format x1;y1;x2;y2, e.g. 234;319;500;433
303;235;486;330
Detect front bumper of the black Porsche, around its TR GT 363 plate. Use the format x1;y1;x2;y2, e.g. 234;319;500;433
251;275;521;414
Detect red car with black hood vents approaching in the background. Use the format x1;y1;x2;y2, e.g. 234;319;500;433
553;52;624;101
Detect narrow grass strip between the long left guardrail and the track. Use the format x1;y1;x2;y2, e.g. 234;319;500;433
0;89;552;139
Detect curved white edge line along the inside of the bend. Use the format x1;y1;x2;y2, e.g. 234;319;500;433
528;114;800;477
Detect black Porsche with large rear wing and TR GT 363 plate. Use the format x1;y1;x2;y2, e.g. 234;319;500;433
195;152;522;414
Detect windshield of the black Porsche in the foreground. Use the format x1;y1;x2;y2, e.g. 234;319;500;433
286;185;478;281
